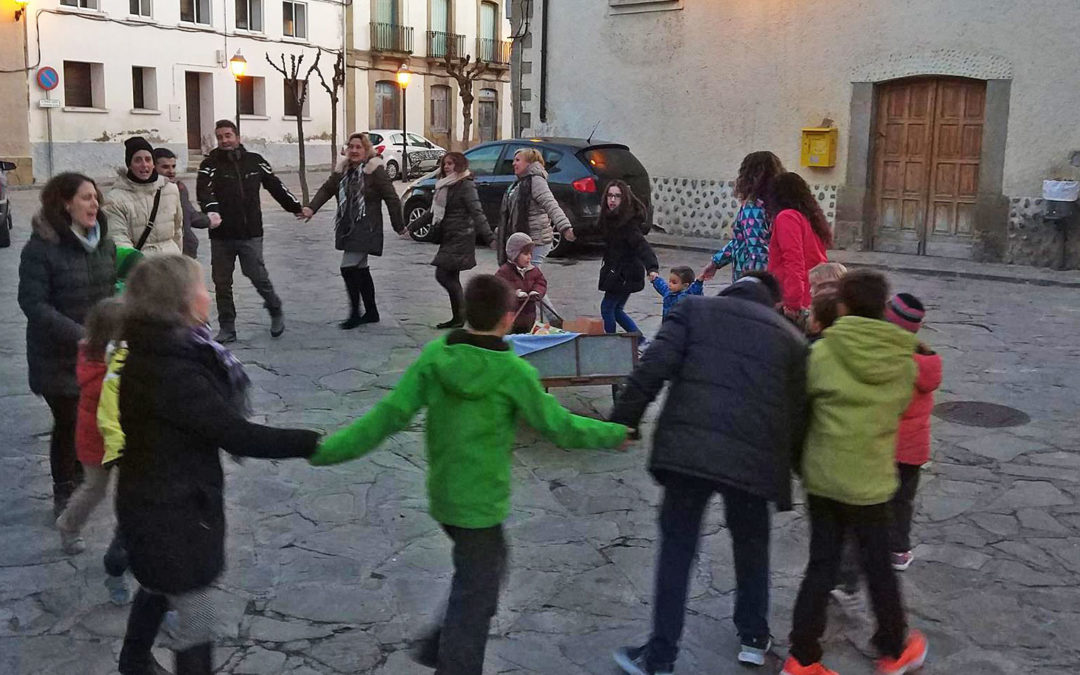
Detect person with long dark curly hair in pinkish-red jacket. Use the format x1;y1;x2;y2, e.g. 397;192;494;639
765;173;833;325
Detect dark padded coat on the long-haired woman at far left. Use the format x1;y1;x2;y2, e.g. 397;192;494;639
18;213;117;397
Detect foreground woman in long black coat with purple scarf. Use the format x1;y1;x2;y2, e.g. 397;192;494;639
117;254;319;675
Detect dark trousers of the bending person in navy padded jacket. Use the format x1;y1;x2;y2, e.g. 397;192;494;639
648;472;770;664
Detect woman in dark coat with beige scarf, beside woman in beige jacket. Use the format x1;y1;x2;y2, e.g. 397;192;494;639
409;152;495;328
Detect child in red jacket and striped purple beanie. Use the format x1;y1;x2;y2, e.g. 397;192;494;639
886;293;942;570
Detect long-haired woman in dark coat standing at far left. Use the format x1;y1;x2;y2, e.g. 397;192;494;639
18;173;117;516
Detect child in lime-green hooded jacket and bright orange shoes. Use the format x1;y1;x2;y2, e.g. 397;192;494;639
782;270;927;675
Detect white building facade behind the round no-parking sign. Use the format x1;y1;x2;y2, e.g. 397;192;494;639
8;0;345;180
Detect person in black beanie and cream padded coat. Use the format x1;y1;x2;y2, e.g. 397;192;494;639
103;136;184;254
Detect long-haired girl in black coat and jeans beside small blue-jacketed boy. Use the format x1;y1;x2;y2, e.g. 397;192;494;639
596;180;660;333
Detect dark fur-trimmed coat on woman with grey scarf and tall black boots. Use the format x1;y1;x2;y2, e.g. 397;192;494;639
308;157;405;256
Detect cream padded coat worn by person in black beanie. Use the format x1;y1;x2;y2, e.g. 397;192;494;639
102;168;184;255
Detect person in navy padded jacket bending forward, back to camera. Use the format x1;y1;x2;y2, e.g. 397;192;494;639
611;272;807;675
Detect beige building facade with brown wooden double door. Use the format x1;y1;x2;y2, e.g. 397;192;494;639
512;0;1080;267
